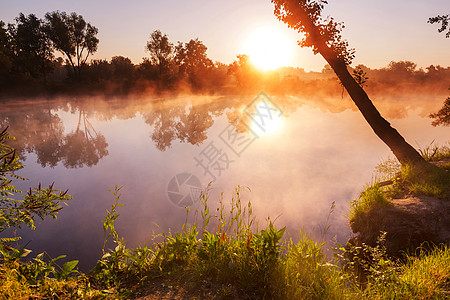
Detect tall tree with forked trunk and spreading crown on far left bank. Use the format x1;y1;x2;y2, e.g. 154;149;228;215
45;11;99;78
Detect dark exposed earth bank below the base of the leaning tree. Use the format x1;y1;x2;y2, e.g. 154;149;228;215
349;159;450;257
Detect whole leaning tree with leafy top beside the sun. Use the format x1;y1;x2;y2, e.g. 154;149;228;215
271;0;425;164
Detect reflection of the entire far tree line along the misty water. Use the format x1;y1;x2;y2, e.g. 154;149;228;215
0;91;441;161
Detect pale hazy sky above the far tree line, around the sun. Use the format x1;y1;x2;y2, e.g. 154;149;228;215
0;0;450;71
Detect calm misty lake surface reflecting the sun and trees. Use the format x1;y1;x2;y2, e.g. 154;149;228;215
0;95;450;270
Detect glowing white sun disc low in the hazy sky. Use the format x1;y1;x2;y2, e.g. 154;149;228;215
244;26;295;71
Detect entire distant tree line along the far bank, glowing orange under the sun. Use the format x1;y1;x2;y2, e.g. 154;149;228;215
0;11;450;99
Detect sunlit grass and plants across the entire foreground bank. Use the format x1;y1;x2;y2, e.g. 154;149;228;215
0;187;450;299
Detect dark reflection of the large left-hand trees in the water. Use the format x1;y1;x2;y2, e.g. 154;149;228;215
0;105;108;168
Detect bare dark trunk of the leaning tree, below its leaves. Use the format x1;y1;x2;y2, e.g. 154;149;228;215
319;48;426;165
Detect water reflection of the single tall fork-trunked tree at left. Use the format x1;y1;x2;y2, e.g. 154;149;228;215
60;110;108;168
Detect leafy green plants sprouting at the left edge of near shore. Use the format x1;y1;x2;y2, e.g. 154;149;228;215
0;128;85;298
